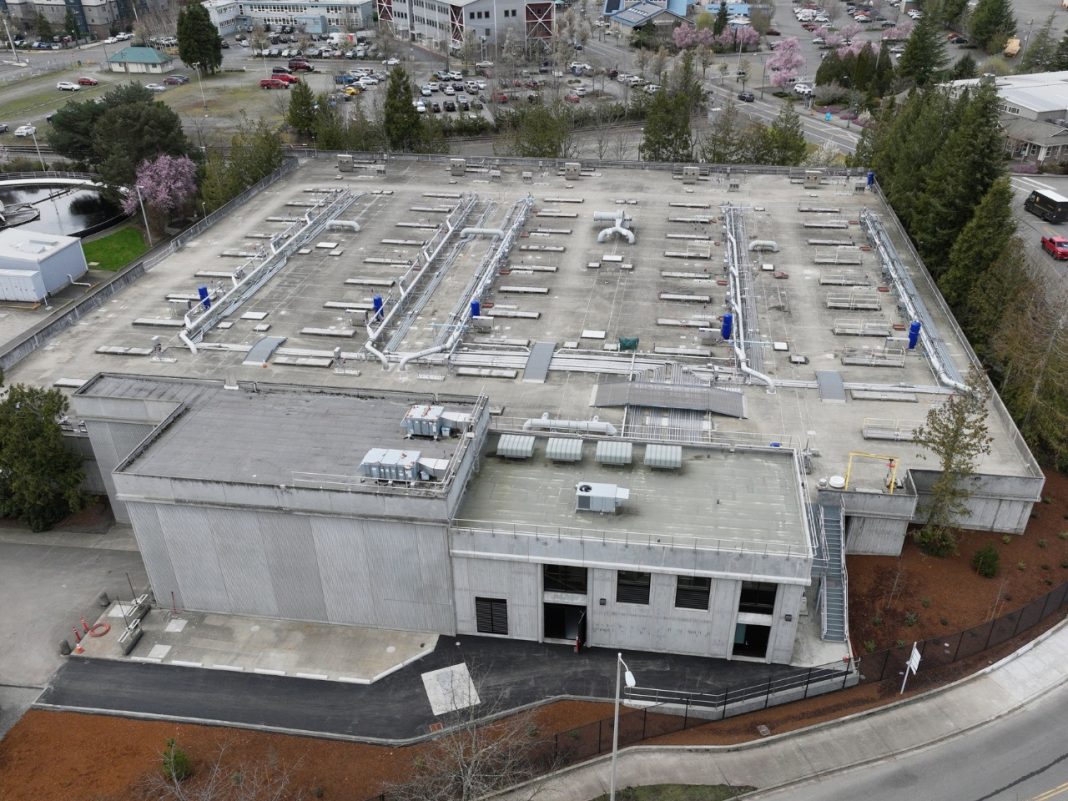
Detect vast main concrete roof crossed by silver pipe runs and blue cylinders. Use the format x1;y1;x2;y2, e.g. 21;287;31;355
9;157;1040;501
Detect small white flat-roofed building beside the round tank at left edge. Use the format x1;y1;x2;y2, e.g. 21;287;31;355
0;229;89;302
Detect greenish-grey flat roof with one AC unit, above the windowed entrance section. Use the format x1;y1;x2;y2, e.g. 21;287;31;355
455;437;808;554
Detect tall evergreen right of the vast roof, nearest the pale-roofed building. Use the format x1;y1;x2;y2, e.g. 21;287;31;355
910;83;1004;278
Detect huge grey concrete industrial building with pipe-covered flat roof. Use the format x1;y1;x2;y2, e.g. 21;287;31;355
0;157;1042;664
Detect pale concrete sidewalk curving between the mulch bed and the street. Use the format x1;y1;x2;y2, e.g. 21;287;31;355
501;621;1068;801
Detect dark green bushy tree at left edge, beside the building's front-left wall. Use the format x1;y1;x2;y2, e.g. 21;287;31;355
0;383;84;531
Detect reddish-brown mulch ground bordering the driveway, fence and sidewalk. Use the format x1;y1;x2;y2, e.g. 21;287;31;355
0;473;1068;801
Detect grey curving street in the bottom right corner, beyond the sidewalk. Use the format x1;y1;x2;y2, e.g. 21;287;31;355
747;670;1068;801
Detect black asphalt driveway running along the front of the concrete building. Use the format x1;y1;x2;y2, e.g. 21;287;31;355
40;637;828;739
